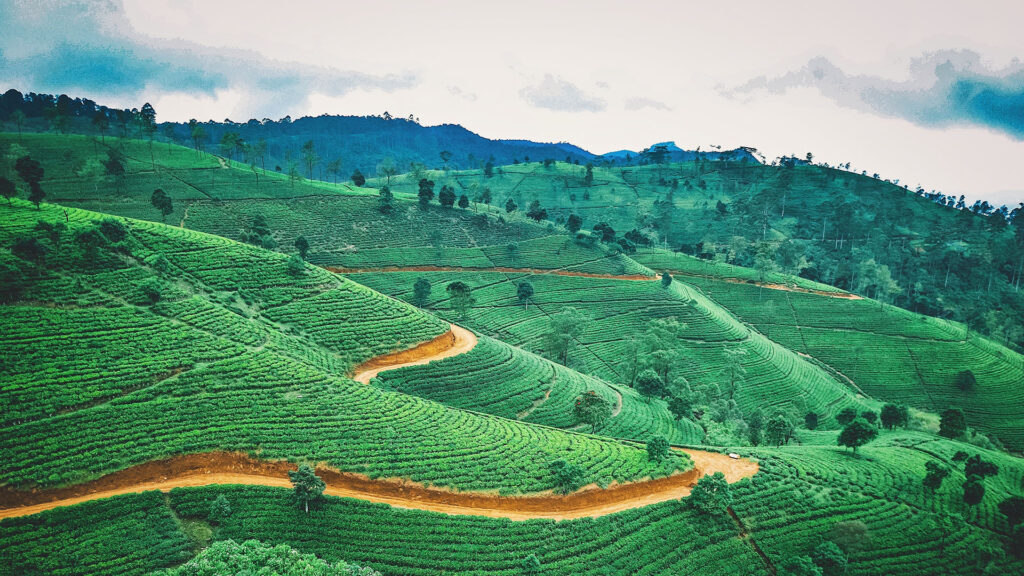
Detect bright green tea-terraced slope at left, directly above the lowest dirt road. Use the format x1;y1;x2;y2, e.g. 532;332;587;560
0;202;686;492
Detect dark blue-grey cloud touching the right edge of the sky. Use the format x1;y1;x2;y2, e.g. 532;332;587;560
725;50;1024;140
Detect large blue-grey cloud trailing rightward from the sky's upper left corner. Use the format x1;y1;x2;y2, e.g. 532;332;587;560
0;0;419;118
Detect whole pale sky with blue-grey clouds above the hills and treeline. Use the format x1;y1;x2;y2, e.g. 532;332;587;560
0;0;1024;207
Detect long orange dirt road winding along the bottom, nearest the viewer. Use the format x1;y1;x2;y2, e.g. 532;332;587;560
0;450;758;520
